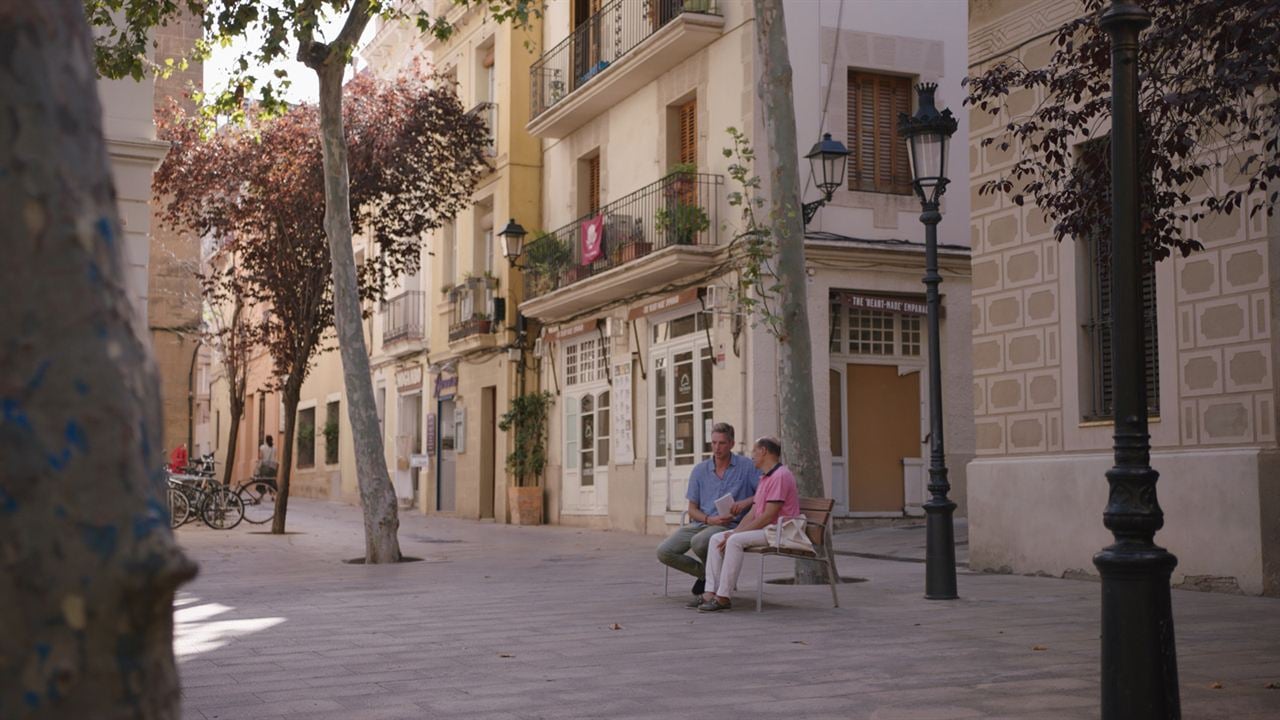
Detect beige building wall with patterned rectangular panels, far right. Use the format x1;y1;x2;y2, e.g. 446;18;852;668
968;0;1280;594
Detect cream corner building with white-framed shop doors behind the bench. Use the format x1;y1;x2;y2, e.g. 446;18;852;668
516;0;973;533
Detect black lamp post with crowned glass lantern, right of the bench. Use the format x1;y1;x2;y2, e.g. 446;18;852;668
897;82;959;600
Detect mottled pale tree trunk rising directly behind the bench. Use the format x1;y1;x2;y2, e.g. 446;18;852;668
754;0;827;583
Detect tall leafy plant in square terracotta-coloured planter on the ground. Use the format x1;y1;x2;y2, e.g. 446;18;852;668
498;392;553;525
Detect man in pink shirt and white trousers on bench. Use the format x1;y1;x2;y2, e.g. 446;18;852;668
698;437;800;612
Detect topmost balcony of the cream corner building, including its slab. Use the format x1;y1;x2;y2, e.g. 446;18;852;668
527;0;724;137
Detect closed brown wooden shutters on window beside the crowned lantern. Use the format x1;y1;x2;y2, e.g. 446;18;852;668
847;69;911;195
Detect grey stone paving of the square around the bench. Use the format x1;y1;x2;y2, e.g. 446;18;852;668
175;500;1280;720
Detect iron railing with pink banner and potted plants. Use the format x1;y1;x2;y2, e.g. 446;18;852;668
525;173;724;299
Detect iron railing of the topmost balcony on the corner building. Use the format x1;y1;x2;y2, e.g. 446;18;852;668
529;0;721;120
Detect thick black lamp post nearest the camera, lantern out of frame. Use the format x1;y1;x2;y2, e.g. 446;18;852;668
1093;1;1181;720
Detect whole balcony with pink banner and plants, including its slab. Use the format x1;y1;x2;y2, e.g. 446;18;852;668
521;172;724;319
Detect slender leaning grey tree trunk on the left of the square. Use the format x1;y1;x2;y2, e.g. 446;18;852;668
307;8;401;562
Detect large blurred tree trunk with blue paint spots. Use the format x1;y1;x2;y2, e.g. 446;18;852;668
0;0;196;720
